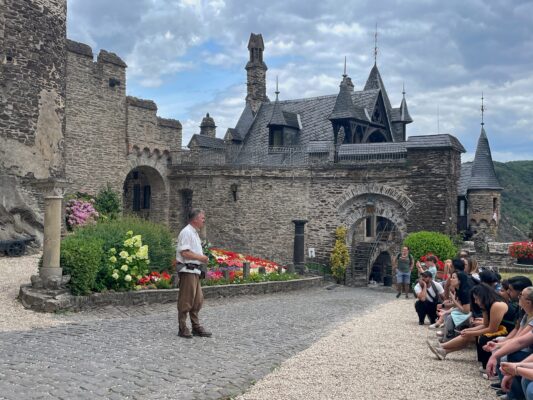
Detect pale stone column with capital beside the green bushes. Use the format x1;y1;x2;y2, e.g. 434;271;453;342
35;179;67;288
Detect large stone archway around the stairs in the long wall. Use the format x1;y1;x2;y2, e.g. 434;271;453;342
335;183;414;286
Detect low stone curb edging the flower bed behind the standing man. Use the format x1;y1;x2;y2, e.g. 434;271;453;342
18;277;323;312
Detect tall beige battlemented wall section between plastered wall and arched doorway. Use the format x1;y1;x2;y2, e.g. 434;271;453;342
65;41;127;194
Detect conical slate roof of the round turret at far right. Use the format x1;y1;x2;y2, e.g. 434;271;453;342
468;127;503;190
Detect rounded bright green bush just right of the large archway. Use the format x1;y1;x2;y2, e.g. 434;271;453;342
403;231;458;261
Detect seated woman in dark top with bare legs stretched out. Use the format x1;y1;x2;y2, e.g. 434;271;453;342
428;283;509;360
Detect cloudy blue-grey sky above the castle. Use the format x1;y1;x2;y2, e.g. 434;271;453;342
67;0;533;161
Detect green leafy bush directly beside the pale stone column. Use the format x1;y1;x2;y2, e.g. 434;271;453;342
60;235;104;296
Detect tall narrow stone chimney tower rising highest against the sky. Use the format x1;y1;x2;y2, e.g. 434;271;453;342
245;33;269;114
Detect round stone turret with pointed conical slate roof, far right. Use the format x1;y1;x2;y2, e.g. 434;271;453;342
467;127;503;242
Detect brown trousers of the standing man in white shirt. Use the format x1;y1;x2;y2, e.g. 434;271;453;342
178;272;204;331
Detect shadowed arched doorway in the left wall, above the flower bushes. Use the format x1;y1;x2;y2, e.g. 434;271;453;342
122;166;168;223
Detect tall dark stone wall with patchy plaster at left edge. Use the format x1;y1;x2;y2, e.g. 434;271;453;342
0;0;66;241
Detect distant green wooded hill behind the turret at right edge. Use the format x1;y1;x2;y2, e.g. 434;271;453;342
494;161;533;242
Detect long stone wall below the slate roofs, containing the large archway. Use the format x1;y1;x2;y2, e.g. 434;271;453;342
169;145;459;263
